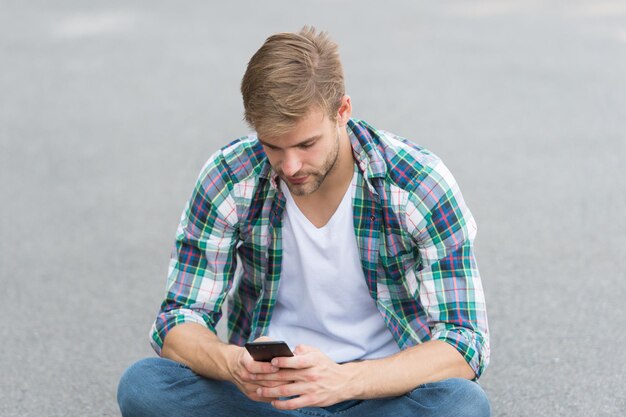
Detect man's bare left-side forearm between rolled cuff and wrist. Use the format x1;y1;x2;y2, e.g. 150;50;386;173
161;323;241;381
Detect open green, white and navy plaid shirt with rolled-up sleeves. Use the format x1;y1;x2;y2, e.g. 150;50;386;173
151;119;489;375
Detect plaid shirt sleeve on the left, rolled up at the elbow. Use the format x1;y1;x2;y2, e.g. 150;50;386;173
150;152;237;355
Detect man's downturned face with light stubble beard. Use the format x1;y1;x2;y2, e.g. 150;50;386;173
259;108;339;196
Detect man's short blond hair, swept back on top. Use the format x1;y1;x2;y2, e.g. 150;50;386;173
241;26;345;135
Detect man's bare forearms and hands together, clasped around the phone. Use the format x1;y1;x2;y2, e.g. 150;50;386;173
161;323;476;409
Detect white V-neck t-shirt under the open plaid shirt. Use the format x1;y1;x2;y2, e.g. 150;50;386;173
268;174;399;363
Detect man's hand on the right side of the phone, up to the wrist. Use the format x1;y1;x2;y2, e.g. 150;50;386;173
252;345;352;410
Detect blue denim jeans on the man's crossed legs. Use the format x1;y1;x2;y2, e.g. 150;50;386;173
117;358;491;417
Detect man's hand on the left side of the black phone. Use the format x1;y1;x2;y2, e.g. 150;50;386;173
229;337;288;402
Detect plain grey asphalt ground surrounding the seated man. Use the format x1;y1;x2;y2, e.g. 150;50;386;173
0;0;626;417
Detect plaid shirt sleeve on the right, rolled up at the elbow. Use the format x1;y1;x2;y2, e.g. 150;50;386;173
407;160;489;377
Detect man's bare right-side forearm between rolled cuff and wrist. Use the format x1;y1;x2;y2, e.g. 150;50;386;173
343;340;476;399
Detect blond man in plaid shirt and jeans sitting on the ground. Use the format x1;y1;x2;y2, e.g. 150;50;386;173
118;28;490;417
